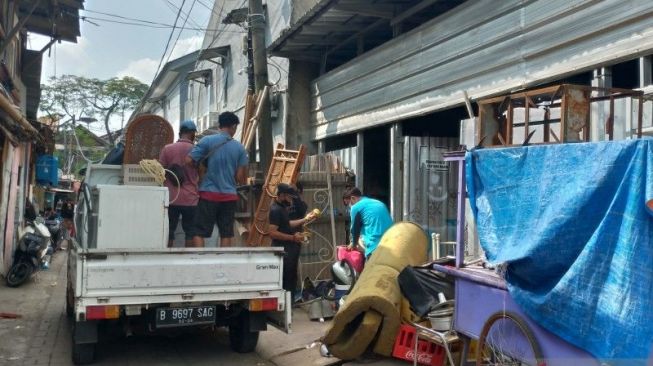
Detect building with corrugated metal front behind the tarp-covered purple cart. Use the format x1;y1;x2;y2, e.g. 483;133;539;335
268;0;653;240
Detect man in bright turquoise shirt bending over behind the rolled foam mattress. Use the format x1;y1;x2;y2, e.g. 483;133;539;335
344;187;392;259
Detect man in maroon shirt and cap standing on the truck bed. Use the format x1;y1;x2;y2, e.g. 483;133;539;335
159;120;198;248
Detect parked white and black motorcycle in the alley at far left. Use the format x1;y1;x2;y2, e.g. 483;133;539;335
7;217;52;287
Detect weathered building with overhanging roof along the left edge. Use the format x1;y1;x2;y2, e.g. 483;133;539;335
0;0;83;275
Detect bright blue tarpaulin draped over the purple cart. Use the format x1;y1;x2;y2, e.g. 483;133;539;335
466;140;653;362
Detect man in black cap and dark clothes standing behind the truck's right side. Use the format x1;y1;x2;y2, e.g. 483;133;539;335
268;183;315;299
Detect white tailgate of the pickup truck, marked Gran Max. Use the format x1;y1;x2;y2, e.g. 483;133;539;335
76;247;283;304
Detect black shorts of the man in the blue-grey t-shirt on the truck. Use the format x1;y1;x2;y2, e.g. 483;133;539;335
193;198;238;238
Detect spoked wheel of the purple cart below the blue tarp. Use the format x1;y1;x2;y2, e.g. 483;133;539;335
476;312;546;366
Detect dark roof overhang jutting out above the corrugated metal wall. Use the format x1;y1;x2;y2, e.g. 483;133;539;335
268;0;462;62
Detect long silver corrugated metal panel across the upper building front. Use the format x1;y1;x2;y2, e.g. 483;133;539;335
311;0;653;139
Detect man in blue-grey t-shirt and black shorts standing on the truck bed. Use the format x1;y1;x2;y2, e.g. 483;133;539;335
186;112;249;247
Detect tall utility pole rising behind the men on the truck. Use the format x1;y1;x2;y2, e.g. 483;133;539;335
249;0;272;172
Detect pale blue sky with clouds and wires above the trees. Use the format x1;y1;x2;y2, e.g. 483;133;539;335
28;0;213;85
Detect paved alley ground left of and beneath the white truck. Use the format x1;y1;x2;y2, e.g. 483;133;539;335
0;252;273;366
